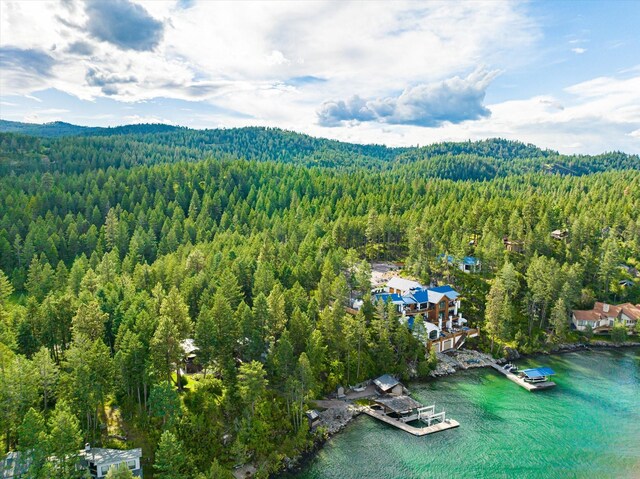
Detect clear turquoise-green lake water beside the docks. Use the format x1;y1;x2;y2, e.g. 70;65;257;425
283;349;640;479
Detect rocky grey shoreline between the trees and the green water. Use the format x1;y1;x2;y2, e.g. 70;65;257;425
271;341;640;479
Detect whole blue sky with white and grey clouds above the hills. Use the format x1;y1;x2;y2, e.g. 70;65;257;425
0;0;640;154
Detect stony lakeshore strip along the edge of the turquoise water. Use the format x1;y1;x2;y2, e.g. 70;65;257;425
276;341;640;479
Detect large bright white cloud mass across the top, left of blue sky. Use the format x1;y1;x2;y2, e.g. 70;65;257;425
0;0;538;102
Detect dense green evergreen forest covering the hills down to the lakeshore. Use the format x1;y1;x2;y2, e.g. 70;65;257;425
0;122;640;479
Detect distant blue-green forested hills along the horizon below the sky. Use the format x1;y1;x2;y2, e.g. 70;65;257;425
0;121;640;176
